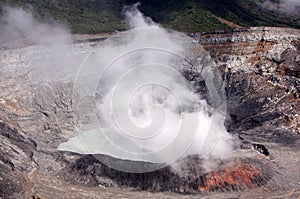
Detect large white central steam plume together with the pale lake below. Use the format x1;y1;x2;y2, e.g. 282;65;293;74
59;4;237;172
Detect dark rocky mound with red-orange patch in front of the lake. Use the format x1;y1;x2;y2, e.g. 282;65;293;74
59;155;273;194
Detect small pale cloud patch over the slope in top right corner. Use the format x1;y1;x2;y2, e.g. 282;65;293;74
262;0;300;16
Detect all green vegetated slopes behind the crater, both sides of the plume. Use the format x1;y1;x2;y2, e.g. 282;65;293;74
0;0;300;33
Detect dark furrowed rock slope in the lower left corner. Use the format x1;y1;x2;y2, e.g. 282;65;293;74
0;121;35;198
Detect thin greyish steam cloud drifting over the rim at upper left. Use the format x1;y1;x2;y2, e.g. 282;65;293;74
0;7;71;46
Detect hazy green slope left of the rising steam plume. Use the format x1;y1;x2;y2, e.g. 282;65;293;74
0;0;126;33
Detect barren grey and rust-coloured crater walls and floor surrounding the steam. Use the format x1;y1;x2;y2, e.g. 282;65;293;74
0;28;300;198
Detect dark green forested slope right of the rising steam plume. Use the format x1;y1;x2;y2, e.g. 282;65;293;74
137;0;300;32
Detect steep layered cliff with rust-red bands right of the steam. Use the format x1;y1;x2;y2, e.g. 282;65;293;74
195;28;300;134
